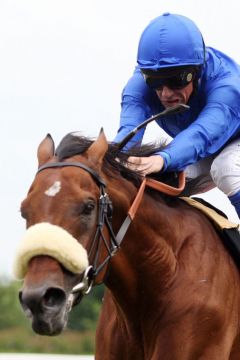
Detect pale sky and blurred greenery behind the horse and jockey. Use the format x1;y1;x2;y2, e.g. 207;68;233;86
0;0;240;354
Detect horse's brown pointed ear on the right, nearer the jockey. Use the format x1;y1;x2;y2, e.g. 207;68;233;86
87;129;108;165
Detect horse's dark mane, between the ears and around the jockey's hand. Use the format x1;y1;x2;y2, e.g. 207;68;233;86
55;133;176;186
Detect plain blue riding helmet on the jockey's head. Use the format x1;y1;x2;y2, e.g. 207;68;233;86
137;13;205;71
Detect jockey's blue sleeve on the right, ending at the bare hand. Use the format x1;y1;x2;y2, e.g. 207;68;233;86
159;82;240;171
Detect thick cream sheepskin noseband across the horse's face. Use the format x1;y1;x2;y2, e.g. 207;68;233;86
14;223;88;279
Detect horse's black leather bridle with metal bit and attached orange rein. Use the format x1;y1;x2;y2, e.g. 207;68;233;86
37;162;185;297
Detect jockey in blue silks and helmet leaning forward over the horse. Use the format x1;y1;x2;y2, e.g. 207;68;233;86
114;13;240;217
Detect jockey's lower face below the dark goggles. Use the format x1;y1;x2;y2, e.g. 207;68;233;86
155;81;193;108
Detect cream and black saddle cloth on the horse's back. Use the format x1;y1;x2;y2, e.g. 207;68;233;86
180;197;240;267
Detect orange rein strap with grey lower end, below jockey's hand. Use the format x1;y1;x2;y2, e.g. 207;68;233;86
115;172;185;246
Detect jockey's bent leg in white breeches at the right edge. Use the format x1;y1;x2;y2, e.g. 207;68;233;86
210;139;240;218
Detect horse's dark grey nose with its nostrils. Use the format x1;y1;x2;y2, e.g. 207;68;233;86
19;287;66;316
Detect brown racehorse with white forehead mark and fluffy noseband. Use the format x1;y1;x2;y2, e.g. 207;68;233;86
16;133;240;360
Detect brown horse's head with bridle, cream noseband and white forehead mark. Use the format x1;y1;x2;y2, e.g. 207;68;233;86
15;132;116;335
